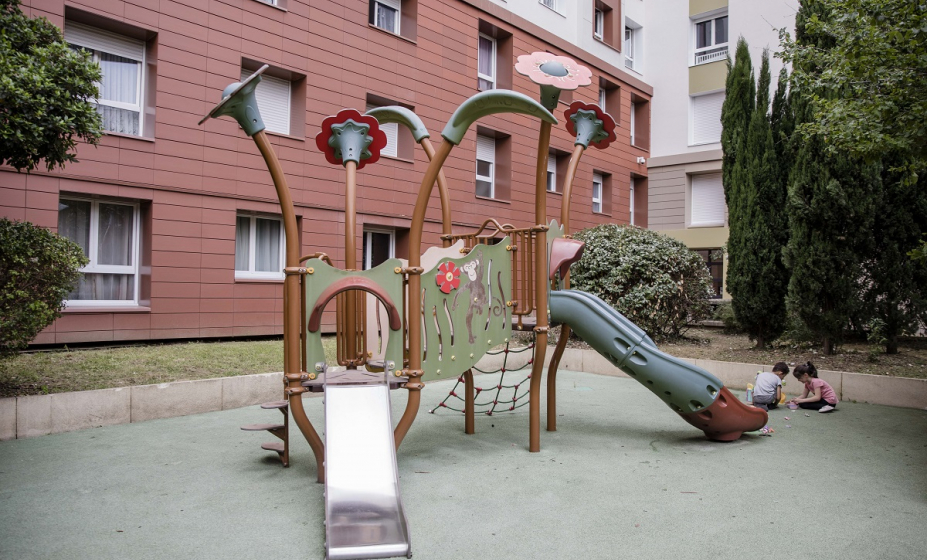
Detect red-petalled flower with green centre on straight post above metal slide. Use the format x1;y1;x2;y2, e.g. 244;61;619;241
315;109;386;169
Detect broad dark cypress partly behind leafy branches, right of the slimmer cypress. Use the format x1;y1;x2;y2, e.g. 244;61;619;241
784;0;879;354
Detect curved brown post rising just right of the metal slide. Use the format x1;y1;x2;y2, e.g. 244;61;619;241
393;140;454;449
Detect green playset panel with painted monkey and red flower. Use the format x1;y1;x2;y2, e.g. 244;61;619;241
421;237;512;380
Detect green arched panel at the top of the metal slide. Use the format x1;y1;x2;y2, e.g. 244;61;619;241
303;259;405;371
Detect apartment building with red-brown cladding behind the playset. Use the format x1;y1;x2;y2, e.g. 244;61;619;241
0;0;653;344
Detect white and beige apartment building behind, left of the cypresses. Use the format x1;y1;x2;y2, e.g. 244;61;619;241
640;0;797;298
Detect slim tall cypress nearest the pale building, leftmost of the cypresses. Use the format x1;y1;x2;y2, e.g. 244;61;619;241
721;42;788;348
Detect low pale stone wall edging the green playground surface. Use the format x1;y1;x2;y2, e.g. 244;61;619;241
0;348;927;441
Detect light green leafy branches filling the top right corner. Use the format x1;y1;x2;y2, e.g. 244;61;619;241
780;0;927;166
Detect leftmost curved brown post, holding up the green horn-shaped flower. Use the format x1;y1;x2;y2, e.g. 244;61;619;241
253;130;325;482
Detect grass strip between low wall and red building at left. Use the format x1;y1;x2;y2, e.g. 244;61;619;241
0;337;335;397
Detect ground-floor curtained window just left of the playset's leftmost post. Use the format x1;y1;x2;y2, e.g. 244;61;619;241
235;215;284;280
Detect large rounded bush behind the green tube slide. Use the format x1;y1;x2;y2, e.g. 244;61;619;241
570;224;711;339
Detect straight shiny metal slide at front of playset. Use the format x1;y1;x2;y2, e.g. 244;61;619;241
325;382;412;560
